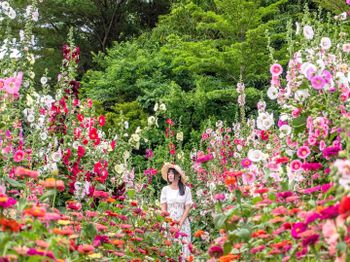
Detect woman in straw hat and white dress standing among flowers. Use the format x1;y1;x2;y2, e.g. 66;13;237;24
160;163;193;258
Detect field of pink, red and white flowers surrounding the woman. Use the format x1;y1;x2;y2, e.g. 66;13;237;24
0;2;350;262
